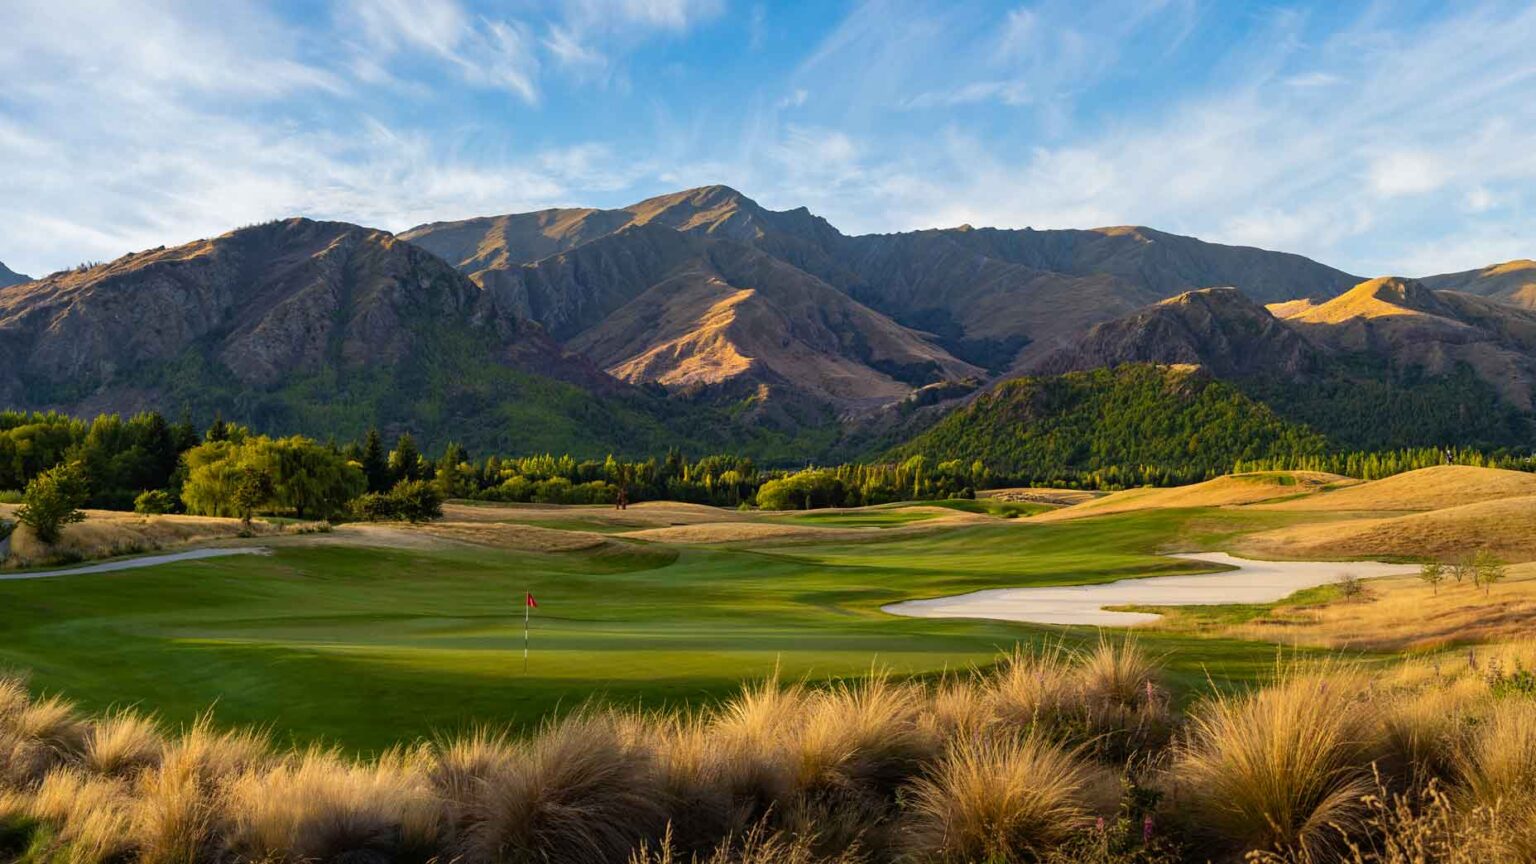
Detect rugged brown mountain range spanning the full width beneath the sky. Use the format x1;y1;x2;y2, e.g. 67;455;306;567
0;186;1536;461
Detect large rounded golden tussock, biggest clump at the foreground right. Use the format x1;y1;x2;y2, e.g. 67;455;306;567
1172;669;1375;861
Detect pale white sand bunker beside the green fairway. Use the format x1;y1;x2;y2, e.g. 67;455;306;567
882;552;1415;627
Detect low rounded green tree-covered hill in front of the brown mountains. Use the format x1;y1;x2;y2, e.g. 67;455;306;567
891;364;1324;484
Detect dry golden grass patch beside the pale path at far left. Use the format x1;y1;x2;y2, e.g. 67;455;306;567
0;504;283;567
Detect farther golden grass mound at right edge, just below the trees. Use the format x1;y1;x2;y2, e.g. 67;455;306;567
1256;464;1536;510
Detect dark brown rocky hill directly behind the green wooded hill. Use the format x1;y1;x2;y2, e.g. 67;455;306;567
1031;287;1321;377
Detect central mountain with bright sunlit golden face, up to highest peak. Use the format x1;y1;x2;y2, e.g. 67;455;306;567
409;188;982;409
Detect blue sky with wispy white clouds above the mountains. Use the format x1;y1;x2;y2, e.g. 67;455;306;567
0;0;1536;275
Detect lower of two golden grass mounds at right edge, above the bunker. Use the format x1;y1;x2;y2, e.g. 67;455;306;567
1238;497;1536;561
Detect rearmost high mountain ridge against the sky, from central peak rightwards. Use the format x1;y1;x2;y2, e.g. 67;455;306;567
402;186;1358;379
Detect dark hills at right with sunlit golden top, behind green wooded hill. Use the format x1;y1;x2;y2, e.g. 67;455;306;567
1025;277;1536;449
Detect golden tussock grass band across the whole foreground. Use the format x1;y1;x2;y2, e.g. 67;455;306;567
0;643;1536;864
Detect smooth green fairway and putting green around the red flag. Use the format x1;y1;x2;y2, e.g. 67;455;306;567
0;510;1333;750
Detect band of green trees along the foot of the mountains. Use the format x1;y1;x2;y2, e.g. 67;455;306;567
0;402;1536;527
